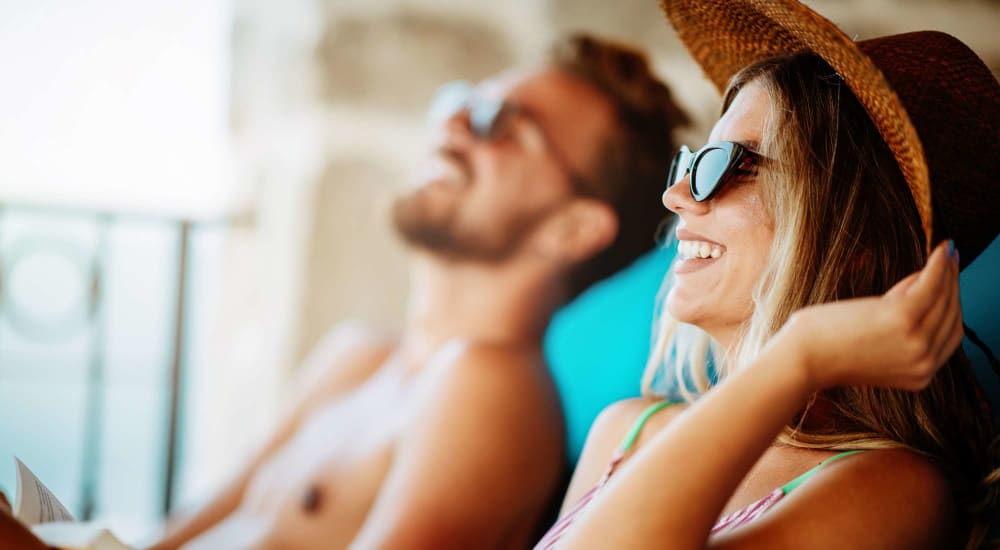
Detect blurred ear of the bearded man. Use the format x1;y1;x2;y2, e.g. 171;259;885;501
535;198;618;264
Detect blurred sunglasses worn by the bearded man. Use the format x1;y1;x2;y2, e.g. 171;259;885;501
427;80;591;194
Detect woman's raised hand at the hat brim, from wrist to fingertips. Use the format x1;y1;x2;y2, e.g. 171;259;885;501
774;241;963;390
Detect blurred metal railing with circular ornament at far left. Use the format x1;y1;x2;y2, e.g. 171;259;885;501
0;203;233;520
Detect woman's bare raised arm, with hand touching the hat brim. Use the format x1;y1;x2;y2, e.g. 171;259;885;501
560;242;962;550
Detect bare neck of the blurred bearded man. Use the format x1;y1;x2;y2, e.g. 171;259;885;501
400;257;561;370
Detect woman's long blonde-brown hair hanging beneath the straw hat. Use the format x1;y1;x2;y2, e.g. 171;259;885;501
643;54;998;548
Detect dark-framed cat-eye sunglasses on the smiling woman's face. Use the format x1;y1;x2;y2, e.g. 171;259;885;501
667;141;760;202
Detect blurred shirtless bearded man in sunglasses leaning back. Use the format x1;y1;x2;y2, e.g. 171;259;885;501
157;36;686;550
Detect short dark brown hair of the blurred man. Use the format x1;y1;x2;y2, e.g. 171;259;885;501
546;34;689;299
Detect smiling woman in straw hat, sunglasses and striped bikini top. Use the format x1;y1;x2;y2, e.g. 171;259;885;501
538;0;1000;549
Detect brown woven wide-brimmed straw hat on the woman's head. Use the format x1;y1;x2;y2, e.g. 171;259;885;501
660;0;1000;268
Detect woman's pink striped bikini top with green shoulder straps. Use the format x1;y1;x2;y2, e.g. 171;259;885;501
534;401;861;550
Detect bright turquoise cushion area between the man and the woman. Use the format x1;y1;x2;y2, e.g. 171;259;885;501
545;246;676;465
